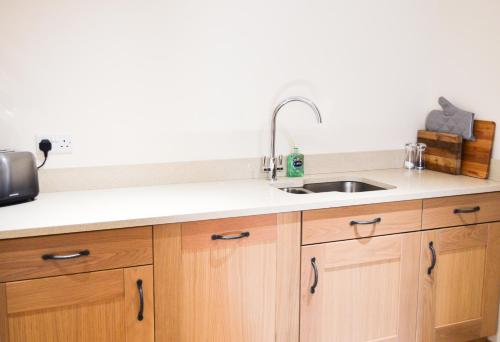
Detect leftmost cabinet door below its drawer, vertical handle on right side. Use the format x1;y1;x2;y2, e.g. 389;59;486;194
0;266;154;342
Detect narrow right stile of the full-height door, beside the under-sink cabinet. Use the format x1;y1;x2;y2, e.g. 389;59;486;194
276;212;301;342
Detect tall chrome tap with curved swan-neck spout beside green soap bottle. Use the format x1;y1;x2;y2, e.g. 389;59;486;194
263;96;323;181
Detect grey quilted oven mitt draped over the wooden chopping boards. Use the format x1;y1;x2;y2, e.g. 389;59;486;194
425;97;475;140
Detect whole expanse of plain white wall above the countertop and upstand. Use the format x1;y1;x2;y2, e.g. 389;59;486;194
0;0;500;167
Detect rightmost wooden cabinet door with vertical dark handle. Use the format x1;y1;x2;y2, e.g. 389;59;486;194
418;223;500;342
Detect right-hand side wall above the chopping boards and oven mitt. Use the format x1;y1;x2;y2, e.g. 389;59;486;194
431;0;500;159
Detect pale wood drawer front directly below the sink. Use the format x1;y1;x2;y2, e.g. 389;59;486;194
302;200;422;245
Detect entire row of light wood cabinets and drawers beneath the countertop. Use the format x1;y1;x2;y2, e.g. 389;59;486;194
0;193;500;342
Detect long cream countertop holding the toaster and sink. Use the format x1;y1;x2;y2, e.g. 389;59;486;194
0;169;500;239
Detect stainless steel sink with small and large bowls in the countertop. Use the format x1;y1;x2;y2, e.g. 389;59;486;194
280;180;388;194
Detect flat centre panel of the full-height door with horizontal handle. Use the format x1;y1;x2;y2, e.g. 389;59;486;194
180;220;276;342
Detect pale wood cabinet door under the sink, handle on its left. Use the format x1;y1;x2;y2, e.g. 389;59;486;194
300;232;421;342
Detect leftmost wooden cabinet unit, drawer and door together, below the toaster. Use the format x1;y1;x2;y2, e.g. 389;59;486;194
0;227;154;342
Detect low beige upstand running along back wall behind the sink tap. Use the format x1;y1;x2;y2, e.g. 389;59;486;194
39;150;403;192
